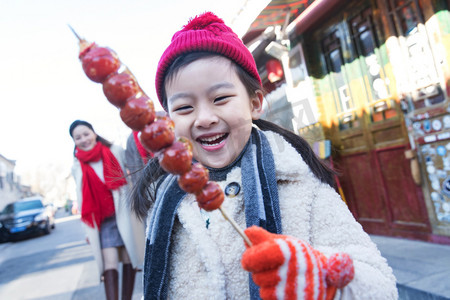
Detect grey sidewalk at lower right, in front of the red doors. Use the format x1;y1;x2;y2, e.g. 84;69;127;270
370;235;450;300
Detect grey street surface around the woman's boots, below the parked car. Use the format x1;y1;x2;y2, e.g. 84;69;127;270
0;210;142;300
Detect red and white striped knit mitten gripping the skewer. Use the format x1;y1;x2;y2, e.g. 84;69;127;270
241;226;354;300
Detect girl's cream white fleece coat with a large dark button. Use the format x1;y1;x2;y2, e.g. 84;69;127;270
164;132;398;300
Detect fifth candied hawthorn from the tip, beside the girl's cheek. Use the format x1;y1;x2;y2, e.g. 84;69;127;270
159;139;192;175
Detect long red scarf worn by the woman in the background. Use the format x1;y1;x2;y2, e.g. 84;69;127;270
75;142;127;228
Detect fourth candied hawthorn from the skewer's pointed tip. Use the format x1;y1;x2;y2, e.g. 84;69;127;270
140;118;175;153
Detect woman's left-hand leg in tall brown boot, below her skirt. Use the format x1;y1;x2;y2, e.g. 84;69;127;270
102;247;119;300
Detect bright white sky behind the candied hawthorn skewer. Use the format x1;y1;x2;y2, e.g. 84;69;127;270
0;0;270;180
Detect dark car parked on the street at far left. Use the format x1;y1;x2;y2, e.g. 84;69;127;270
0;197;55;240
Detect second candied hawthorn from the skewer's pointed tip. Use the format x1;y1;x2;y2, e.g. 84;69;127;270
103;72;140;108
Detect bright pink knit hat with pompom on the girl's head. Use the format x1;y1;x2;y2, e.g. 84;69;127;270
156;12;261;105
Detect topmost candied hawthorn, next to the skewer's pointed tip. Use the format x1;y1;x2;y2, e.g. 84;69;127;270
80;45;120;83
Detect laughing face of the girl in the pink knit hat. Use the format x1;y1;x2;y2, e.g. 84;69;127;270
165;57;263;168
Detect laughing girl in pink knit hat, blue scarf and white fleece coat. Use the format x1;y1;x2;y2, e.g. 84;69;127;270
132;13;397;299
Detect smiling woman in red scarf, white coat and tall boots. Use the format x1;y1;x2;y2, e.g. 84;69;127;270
69;120;145;300
